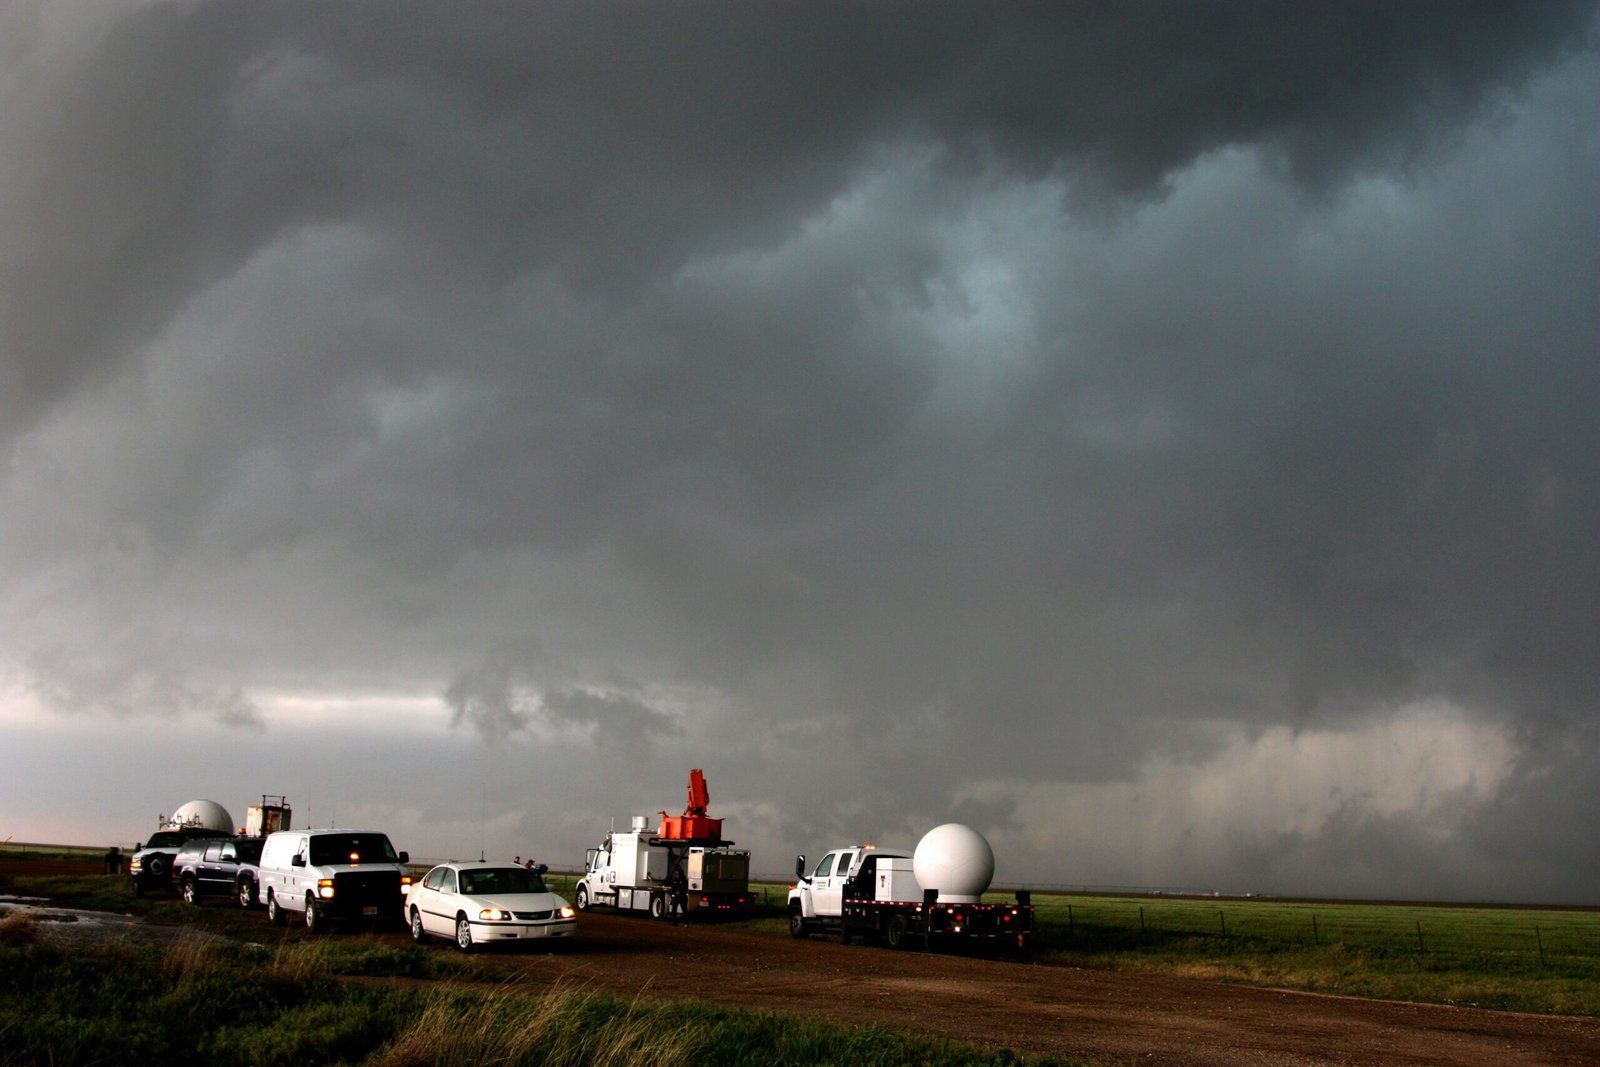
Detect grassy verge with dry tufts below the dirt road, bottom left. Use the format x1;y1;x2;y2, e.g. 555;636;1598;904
0;921;1085;1067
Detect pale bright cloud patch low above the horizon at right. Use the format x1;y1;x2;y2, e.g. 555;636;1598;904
955;702;1525;896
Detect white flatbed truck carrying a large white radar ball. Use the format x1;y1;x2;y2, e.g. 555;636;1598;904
789;822;1034;953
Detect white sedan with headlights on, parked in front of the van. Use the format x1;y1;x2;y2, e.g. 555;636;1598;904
405;862;578;952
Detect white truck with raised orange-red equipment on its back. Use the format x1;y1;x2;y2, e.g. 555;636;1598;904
573;769;750;918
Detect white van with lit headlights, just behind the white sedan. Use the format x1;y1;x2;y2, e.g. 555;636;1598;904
256;830;411;931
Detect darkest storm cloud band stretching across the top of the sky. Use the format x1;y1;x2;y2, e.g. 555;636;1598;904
9;3;1590;424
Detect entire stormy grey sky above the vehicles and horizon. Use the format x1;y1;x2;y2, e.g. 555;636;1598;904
0;0;1600;904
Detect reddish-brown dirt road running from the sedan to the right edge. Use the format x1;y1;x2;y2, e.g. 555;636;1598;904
384;912;1600;1067
